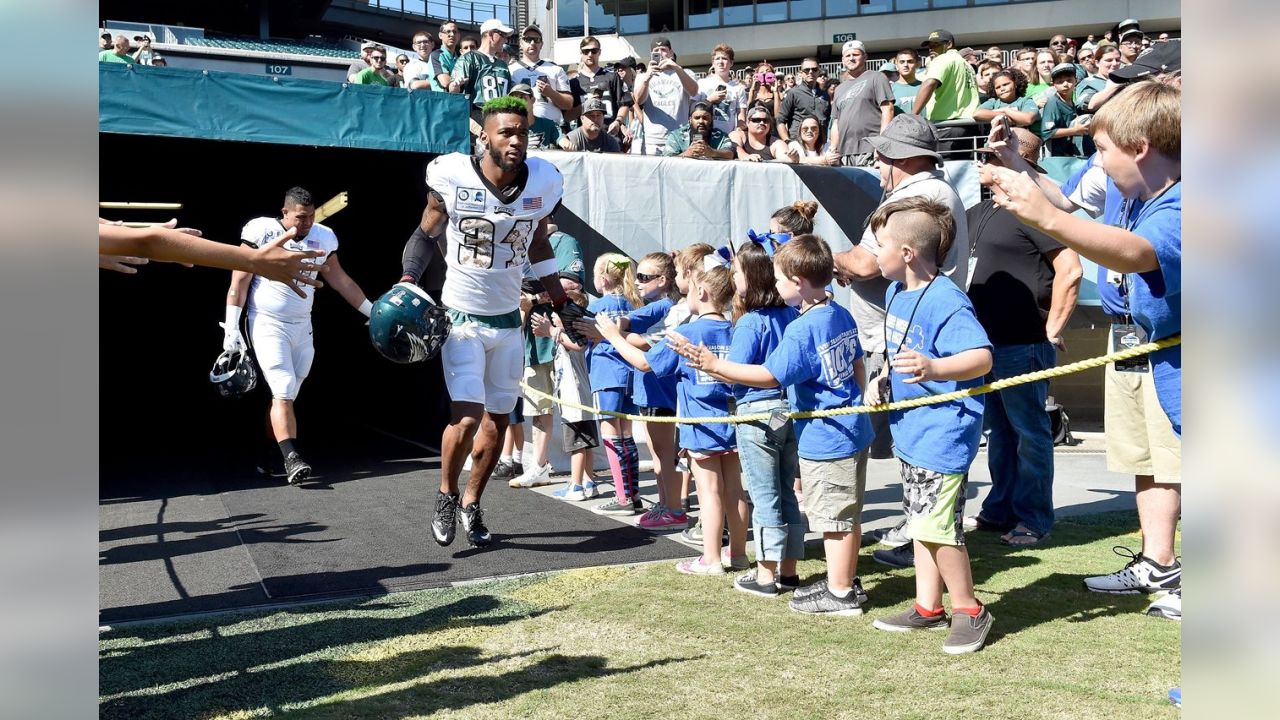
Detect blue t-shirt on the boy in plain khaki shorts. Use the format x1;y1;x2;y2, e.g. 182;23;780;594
764;301;873;460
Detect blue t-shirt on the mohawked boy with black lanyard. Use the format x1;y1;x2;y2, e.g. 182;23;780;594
884;275;992;473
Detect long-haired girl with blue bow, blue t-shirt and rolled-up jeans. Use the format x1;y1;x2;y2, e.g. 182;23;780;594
728;240;805;596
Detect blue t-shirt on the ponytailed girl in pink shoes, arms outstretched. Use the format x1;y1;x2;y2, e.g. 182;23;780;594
645;318;737;452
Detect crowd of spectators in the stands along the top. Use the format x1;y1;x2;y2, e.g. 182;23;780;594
99;19;1169;167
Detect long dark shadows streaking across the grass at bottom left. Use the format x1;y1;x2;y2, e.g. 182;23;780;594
99;594;694;720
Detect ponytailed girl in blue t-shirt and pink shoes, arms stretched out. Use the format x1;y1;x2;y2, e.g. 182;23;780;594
598;265;748;575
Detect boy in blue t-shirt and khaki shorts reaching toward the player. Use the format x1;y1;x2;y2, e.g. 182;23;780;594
677;234;872;615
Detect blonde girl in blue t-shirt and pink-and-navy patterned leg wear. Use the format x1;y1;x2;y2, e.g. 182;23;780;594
588;252;650;515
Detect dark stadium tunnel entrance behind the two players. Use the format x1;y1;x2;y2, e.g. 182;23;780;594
99;133;448;484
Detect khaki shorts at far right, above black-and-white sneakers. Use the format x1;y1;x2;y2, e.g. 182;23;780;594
1105;333;1183;484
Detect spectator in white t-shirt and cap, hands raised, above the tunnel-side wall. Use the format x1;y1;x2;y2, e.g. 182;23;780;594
631;37;698;155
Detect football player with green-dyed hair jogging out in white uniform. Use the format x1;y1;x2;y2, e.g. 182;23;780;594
394;97;565;547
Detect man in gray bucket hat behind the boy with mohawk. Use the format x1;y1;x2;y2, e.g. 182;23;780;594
835;114;969;520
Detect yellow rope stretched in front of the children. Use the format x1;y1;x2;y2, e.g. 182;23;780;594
520;334;1183;424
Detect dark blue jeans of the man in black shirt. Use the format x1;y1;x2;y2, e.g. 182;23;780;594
980;342;1057;533
